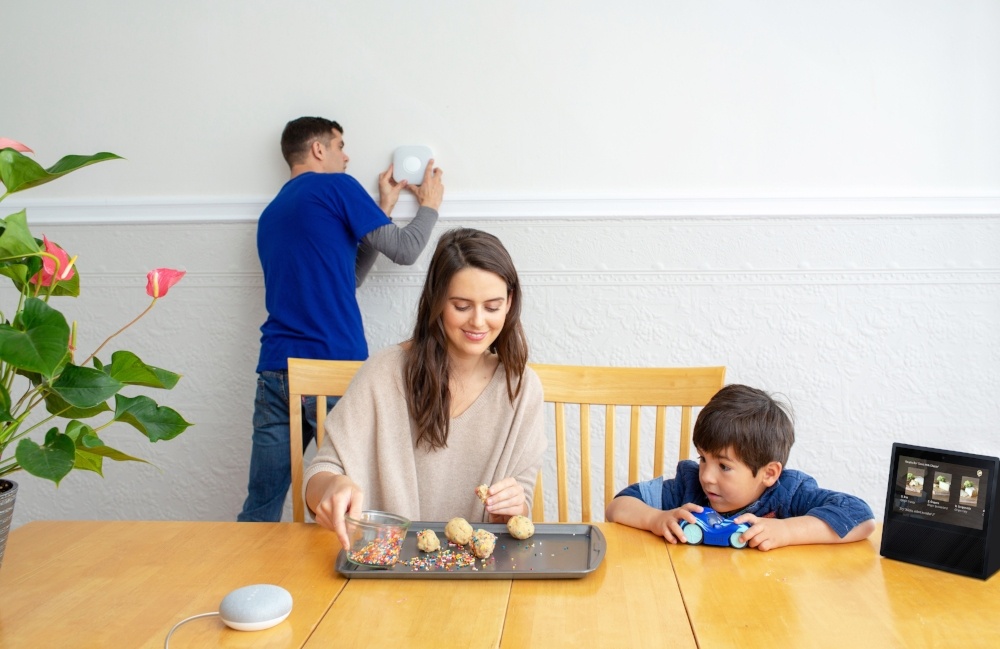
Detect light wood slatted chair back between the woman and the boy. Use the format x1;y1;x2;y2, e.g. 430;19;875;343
531;364;726;522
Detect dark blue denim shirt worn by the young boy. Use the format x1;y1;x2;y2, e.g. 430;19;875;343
615;460;875;538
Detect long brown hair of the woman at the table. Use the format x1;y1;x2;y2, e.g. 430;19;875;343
403;228;528;449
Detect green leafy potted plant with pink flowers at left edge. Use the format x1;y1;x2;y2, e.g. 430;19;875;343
0;138;191;563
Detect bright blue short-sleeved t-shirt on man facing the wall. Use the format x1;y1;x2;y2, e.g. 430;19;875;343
257;172;391;372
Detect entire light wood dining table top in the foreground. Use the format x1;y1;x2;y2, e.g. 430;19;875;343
0;521;1000;649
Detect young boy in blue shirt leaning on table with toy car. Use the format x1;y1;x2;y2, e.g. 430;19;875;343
605;385;875;550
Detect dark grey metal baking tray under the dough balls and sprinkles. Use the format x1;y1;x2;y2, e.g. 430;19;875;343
336;521;608;579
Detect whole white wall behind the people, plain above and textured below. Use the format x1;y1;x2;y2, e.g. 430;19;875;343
0;0;1000;524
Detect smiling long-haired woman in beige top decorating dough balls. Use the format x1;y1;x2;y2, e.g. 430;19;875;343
304;228;546;547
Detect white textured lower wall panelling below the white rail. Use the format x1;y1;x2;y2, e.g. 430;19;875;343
0;210;1000;525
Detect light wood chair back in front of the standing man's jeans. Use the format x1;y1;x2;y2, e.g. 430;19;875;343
288;358;361;523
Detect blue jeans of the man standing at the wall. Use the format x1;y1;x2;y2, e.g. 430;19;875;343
236;370;339;522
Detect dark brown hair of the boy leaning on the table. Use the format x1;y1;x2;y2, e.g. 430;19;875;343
693;384;795;475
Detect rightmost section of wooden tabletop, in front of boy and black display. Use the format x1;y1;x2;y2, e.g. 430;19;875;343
668;525;1000;649
